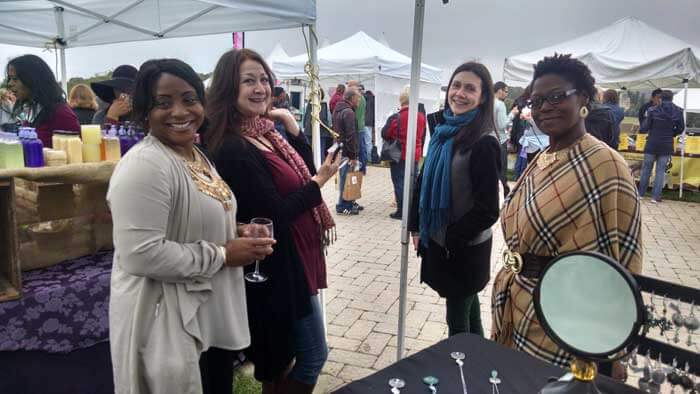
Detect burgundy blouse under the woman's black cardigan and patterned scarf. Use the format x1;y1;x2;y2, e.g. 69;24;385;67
262;151;328;295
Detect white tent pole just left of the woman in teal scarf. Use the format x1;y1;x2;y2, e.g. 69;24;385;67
396;0;425;360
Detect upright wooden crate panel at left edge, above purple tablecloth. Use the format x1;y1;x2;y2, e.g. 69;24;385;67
0;178;22;302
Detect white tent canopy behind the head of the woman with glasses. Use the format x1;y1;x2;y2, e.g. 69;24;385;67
503;17;700;89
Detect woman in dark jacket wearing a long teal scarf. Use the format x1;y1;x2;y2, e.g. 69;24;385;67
409;62;503;336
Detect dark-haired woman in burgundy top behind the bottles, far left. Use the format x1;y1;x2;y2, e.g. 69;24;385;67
6;55;80;148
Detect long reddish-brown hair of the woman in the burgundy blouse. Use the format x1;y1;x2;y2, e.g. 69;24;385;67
203;48;275;153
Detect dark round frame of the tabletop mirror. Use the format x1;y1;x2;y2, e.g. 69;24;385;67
533;251;646;361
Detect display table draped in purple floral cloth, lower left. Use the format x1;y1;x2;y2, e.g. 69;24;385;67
0;251;114;394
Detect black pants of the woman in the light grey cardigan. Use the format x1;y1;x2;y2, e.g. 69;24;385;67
199;347;237;394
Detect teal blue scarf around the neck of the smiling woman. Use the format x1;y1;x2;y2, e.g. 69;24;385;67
418;108;479;247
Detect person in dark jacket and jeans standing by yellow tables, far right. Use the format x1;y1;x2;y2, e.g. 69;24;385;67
639;90;685;203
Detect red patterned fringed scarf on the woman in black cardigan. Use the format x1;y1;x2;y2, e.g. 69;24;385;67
241;117;337;250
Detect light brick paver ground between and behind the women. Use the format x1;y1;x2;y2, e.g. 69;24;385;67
316;167;700;393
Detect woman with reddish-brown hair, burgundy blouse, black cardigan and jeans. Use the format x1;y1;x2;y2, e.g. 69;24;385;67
204;49;340;394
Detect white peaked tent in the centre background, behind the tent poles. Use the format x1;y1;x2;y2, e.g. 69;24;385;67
273;31;442;135
